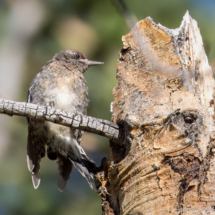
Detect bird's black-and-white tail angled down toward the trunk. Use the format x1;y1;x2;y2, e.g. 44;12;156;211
69;156;98;192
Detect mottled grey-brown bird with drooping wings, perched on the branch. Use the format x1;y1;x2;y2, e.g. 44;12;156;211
27;49;103;191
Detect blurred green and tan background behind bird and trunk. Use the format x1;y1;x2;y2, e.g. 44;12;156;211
0;0;215;215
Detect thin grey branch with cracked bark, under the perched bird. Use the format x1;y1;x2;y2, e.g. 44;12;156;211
0;99;120;143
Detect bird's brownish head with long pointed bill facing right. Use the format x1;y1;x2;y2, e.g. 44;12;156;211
53;49;104;73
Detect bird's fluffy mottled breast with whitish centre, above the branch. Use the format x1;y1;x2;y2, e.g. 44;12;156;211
30;62;88;114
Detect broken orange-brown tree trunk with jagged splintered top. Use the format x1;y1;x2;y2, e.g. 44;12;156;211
102;12;215;215
